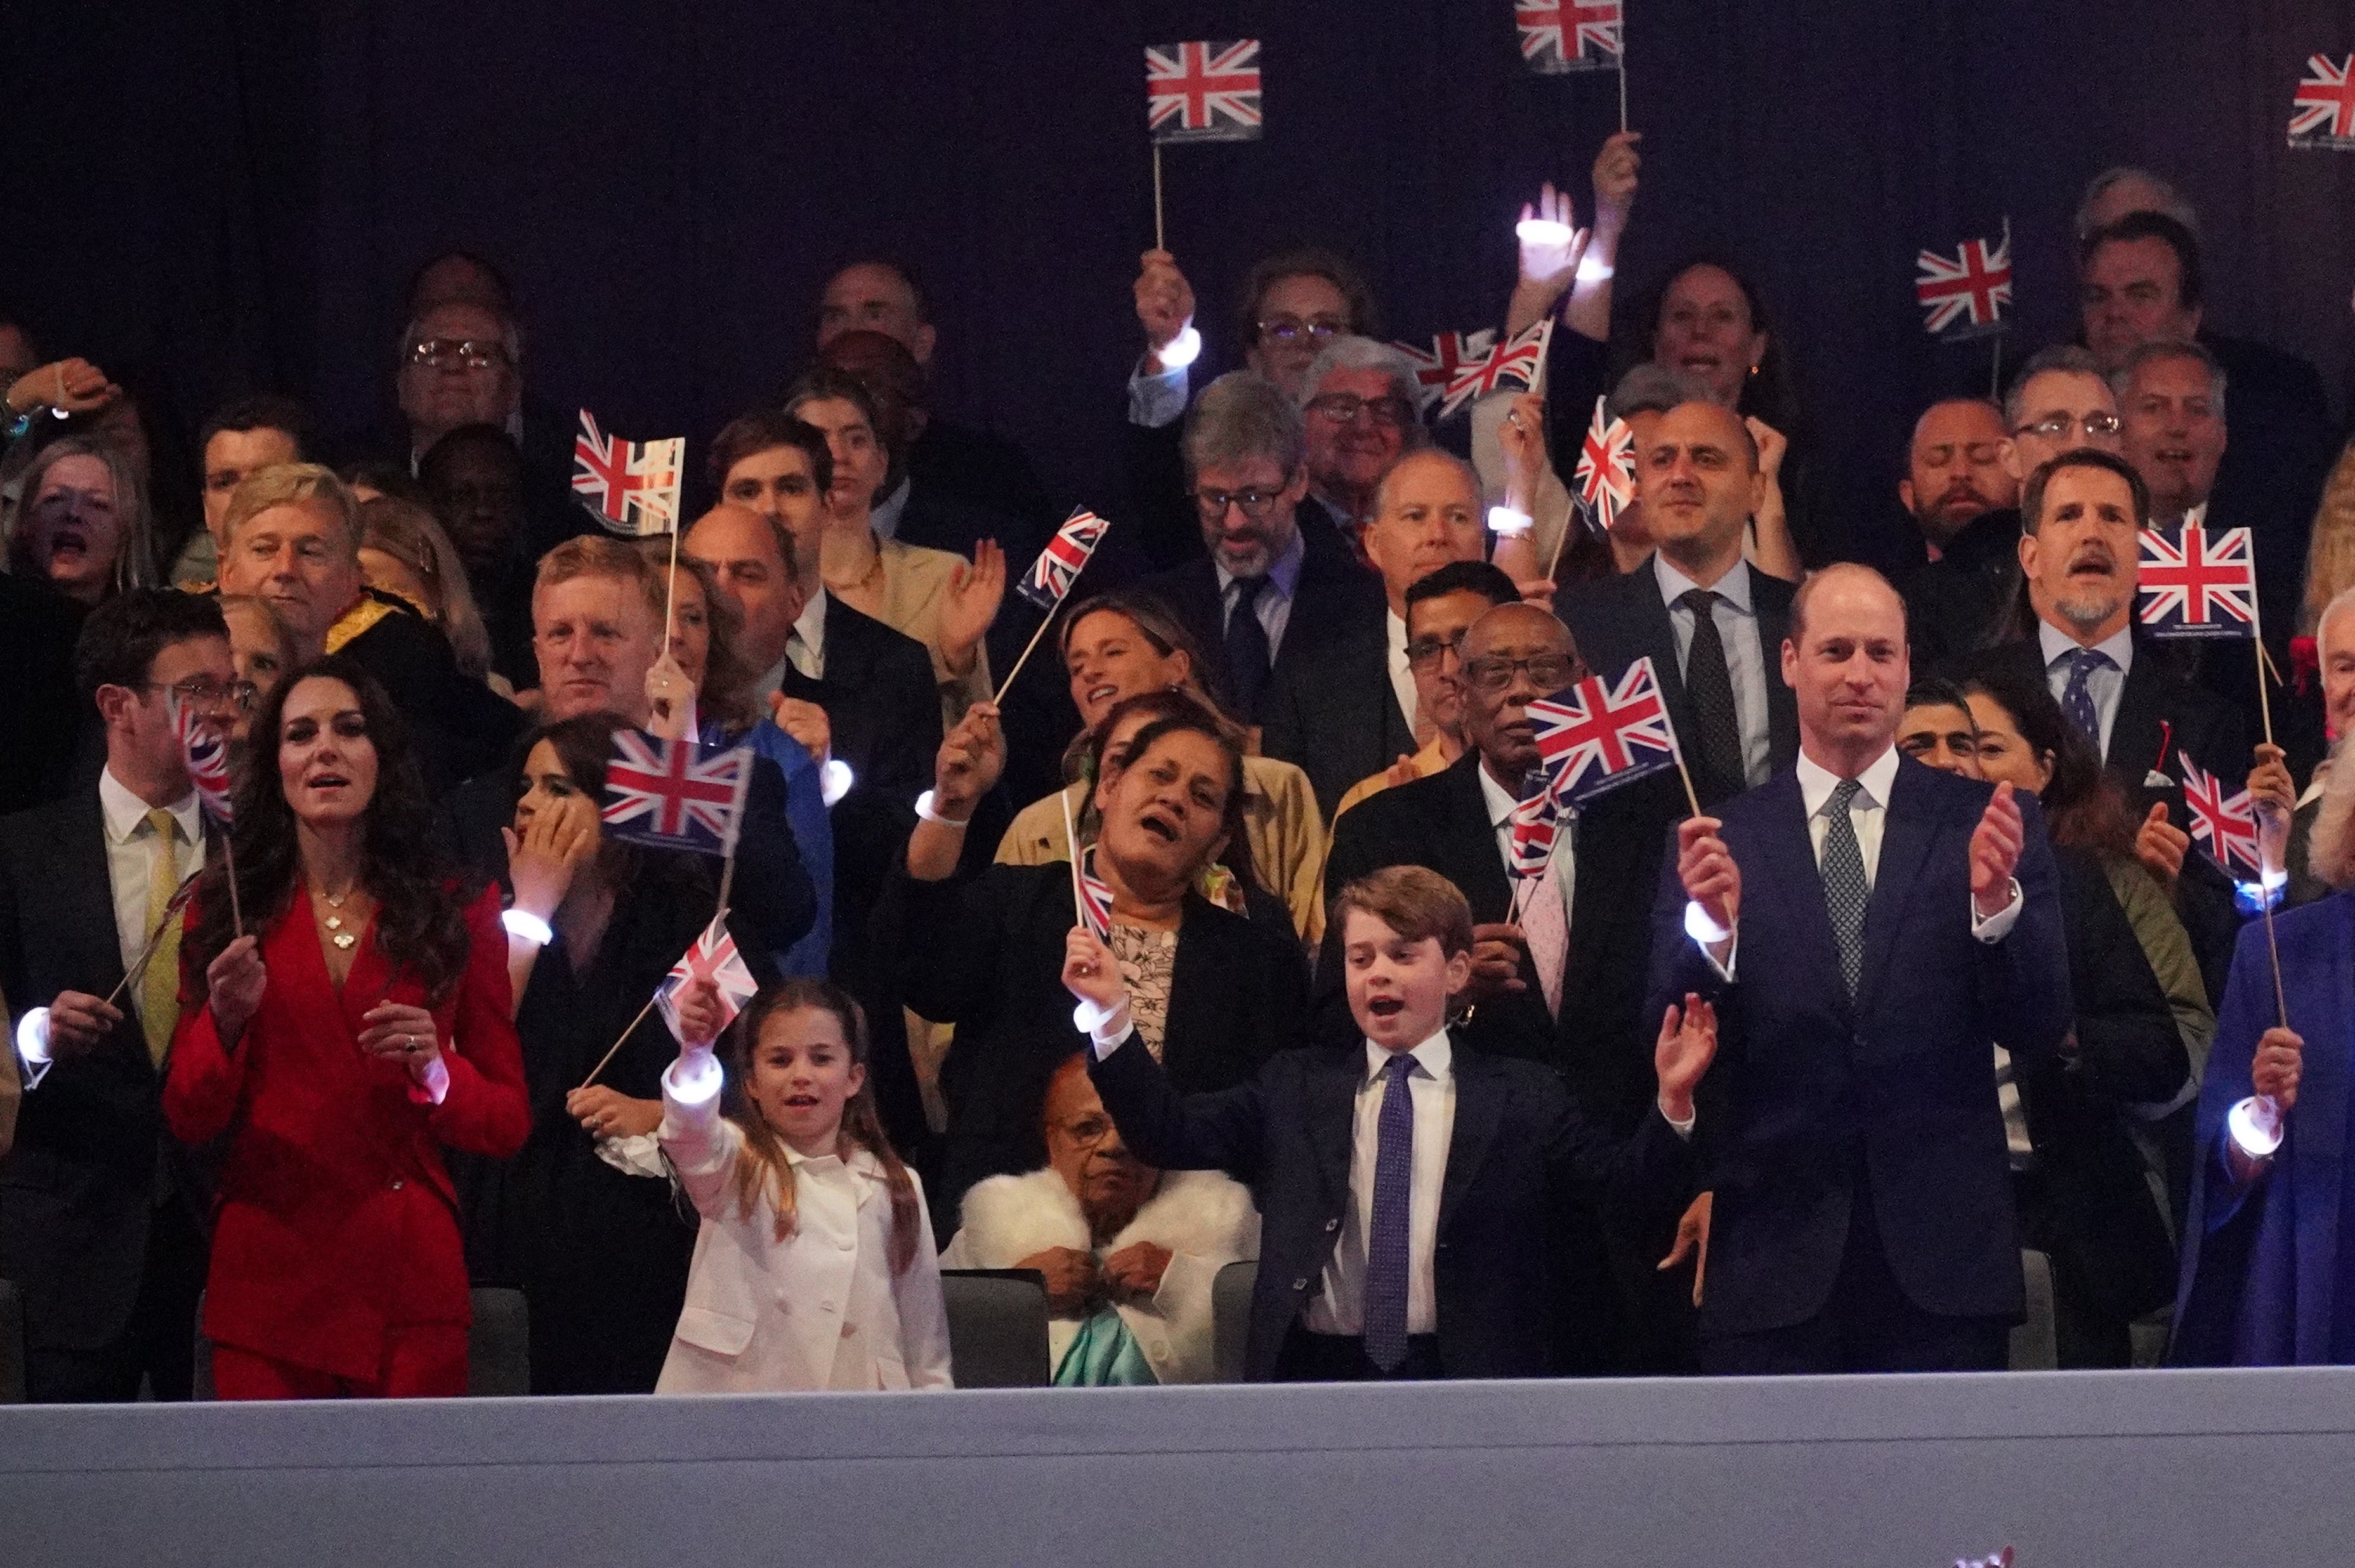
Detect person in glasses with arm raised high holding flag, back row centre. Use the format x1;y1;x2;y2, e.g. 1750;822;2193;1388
1124;249;1378;568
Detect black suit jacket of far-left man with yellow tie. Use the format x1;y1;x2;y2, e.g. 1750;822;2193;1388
0;780;212;1352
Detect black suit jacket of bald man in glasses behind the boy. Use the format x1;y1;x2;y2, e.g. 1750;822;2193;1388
1316;751;1681;1130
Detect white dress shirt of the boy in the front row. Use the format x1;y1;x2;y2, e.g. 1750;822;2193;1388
1300;1029;1455;1335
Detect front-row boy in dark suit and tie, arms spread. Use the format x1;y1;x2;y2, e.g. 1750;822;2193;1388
1062;866;1717;1382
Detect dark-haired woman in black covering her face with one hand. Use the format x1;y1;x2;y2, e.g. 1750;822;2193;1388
473;714;770;1394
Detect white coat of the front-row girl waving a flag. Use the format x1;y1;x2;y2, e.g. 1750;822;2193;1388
655;1069;954;1394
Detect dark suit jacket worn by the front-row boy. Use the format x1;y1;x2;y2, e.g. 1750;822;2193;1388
1088;1036;1691;1382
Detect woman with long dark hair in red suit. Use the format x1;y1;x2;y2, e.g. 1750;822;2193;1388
165;657;532;1399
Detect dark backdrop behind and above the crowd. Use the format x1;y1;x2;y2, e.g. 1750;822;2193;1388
0;0;2355;558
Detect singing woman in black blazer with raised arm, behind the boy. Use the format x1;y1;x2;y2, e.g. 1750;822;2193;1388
876;704;1307;1224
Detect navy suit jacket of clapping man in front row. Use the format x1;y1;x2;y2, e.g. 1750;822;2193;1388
1646;761;2070;1337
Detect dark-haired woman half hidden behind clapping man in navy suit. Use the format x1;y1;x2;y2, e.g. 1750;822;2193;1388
1962;662;2216;1368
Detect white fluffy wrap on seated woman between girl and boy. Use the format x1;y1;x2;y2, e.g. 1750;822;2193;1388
940;1170;1260;1382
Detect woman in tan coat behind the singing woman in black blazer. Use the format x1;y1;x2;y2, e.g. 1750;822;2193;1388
999;593;1326;944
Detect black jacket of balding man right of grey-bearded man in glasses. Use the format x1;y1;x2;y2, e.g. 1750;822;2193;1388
1260;600;1415;821
